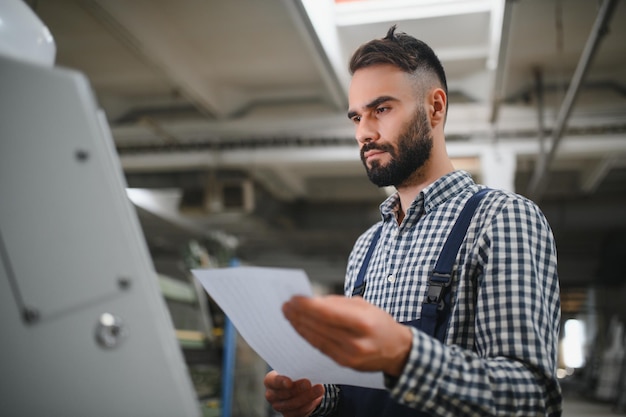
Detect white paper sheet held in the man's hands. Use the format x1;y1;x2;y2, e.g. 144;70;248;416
192;266;384;389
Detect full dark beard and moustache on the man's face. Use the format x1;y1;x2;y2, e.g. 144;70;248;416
361;107;433;187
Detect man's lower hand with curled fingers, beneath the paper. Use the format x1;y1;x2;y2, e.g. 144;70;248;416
263;371;324;417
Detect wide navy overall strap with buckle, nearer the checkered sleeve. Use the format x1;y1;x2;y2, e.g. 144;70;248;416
420;188;491;342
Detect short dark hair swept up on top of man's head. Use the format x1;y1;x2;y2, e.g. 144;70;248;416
349;25;448;95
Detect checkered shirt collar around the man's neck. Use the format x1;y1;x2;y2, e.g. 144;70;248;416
380;170;476;220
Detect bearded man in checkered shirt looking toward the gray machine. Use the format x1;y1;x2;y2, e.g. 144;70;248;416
264;26;561;417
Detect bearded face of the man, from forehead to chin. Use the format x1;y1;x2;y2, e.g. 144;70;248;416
348;64;432;187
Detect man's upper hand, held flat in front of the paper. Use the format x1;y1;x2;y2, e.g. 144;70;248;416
283;295;413;377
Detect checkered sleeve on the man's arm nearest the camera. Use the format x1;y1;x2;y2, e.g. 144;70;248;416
389;197;561;417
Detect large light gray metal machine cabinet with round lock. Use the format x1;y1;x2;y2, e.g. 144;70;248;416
0;51;200;417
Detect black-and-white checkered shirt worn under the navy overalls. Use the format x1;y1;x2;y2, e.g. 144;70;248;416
313;171;562;417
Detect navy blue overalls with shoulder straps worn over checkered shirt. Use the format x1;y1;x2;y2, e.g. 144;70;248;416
338;188;489;417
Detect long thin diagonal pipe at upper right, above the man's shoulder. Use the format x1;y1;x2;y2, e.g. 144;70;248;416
527;0;617;202
